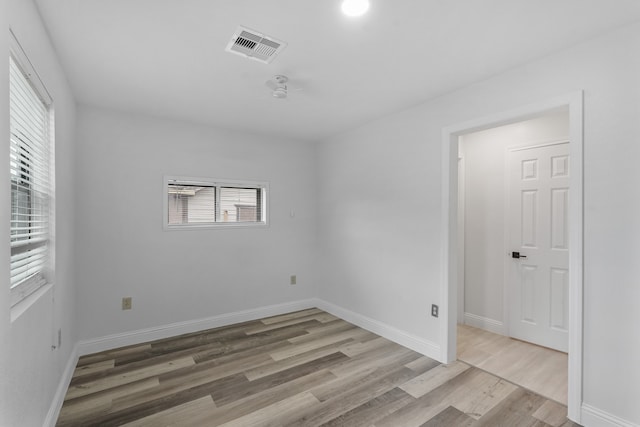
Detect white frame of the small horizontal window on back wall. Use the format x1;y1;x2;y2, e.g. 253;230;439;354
162;175;270;231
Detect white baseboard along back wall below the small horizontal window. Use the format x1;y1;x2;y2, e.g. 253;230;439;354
78;299;316;356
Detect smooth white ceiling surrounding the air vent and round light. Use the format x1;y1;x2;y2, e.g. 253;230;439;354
36;0;640;141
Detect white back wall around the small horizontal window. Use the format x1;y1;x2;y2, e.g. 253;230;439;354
76;107;316;340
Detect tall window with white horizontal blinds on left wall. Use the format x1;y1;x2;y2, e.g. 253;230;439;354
9;45;52;306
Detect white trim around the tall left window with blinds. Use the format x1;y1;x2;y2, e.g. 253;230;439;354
9;29;55;310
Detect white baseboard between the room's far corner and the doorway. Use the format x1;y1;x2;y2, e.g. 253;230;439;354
316;299;440;360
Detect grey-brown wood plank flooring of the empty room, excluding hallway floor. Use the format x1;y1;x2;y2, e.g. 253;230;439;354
57;309;577;427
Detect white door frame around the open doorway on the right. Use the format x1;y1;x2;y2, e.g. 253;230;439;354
439;91;584;423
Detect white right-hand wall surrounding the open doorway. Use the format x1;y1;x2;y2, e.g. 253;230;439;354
317;20;640;424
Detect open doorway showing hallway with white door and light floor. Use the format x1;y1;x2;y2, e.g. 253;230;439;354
457;108;570;406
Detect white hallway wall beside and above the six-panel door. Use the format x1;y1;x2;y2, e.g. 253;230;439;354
459;111;569;334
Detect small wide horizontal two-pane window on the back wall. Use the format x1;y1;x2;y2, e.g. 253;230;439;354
164;177;267;229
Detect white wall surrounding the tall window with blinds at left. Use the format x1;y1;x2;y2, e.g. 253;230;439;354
0;0;76;426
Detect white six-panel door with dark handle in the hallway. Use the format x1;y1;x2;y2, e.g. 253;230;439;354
507;142;569;352
